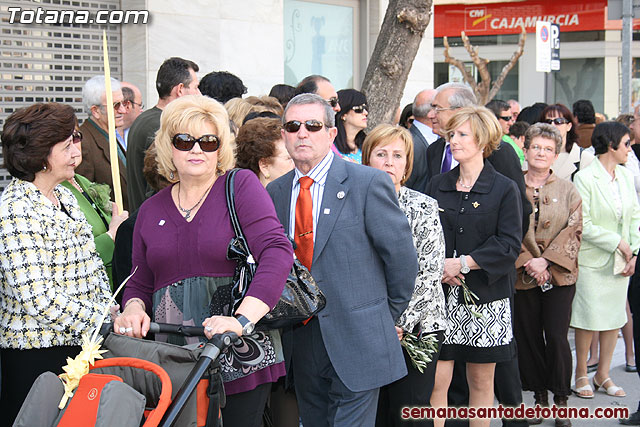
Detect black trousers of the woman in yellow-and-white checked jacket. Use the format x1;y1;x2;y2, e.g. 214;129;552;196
0;346;81;426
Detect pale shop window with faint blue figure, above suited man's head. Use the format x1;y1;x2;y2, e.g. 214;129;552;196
284;0;358;89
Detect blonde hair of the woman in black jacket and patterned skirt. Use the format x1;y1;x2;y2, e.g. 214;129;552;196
445;105;502;159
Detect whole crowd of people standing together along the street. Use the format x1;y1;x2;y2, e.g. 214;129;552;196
0;57;640;427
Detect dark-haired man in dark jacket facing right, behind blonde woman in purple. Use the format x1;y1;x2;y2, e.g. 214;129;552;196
127;57;200;212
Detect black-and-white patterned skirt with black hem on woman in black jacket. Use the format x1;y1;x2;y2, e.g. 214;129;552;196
440;286;515;363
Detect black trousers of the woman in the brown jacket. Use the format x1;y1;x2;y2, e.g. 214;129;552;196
513;285;576;396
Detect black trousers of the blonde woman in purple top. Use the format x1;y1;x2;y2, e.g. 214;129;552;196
222;383;272;427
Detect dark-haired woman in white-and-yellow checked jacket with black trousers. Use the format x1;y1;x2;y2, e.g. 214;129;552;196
0;103;110;425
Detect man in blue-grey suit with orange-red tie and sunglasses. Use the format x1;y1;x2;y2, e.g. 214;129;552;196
267;93;417;427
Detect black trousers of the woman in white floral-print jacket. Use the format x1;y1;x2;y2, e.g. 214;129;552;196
376;331;444;427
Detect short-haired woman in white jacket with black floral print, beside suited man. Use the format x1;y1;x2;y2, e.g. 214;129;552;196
362;124;446;426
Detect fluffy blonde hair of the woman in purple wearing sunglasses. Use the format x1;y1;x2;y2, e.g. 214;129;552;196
154;95;235;183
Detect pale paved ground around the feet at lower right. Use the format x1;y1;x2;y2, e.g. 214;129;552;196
500;329;640;427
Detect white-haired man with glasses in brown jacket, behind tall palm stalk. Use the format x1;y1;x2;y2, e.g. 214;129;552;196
76;76;129;210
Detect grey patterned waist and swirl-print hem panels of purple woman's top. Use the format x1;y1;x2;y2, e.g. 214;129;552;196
153;277;284;382
